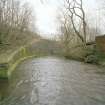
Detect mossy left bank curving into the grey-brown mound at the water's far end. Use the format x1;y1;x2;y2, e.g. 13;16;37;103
0;39;62;78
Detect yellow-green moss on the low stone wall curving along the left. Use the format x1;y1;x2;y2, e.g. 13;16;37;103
0;47;35;78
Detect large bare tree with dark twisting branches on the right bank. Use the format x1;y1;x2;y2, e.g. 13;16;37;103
65;0;87;44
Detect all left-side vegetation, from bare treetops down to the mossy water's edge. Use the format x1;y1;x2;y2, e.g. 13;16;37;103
0;0;40;77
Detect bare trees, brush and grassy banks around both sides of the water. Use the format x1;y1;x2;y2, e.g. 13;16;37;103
0;0;105;77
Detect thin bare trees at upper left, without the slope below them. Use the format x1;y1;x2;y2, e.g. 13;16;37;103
0;0;32;43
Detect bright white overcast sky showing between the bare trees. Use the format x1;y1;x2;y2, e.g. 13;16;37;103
25;0;102;37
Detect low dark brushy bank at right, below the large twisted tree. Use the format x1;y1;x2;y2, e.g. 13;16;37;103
64;46;105;66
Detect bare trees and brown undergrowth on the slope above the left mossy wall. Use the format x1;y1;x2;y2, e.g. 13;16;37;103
0;0;38;50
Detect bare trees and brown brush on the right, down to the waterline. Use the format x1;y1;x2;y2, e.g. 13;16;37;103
59;0;105;63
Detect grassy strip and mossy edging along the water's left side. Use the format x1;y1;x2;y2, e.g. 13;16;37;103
0;46;36;78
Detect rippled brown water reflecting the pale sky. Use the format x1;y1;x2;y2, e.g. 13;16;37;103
0;57;105;105
